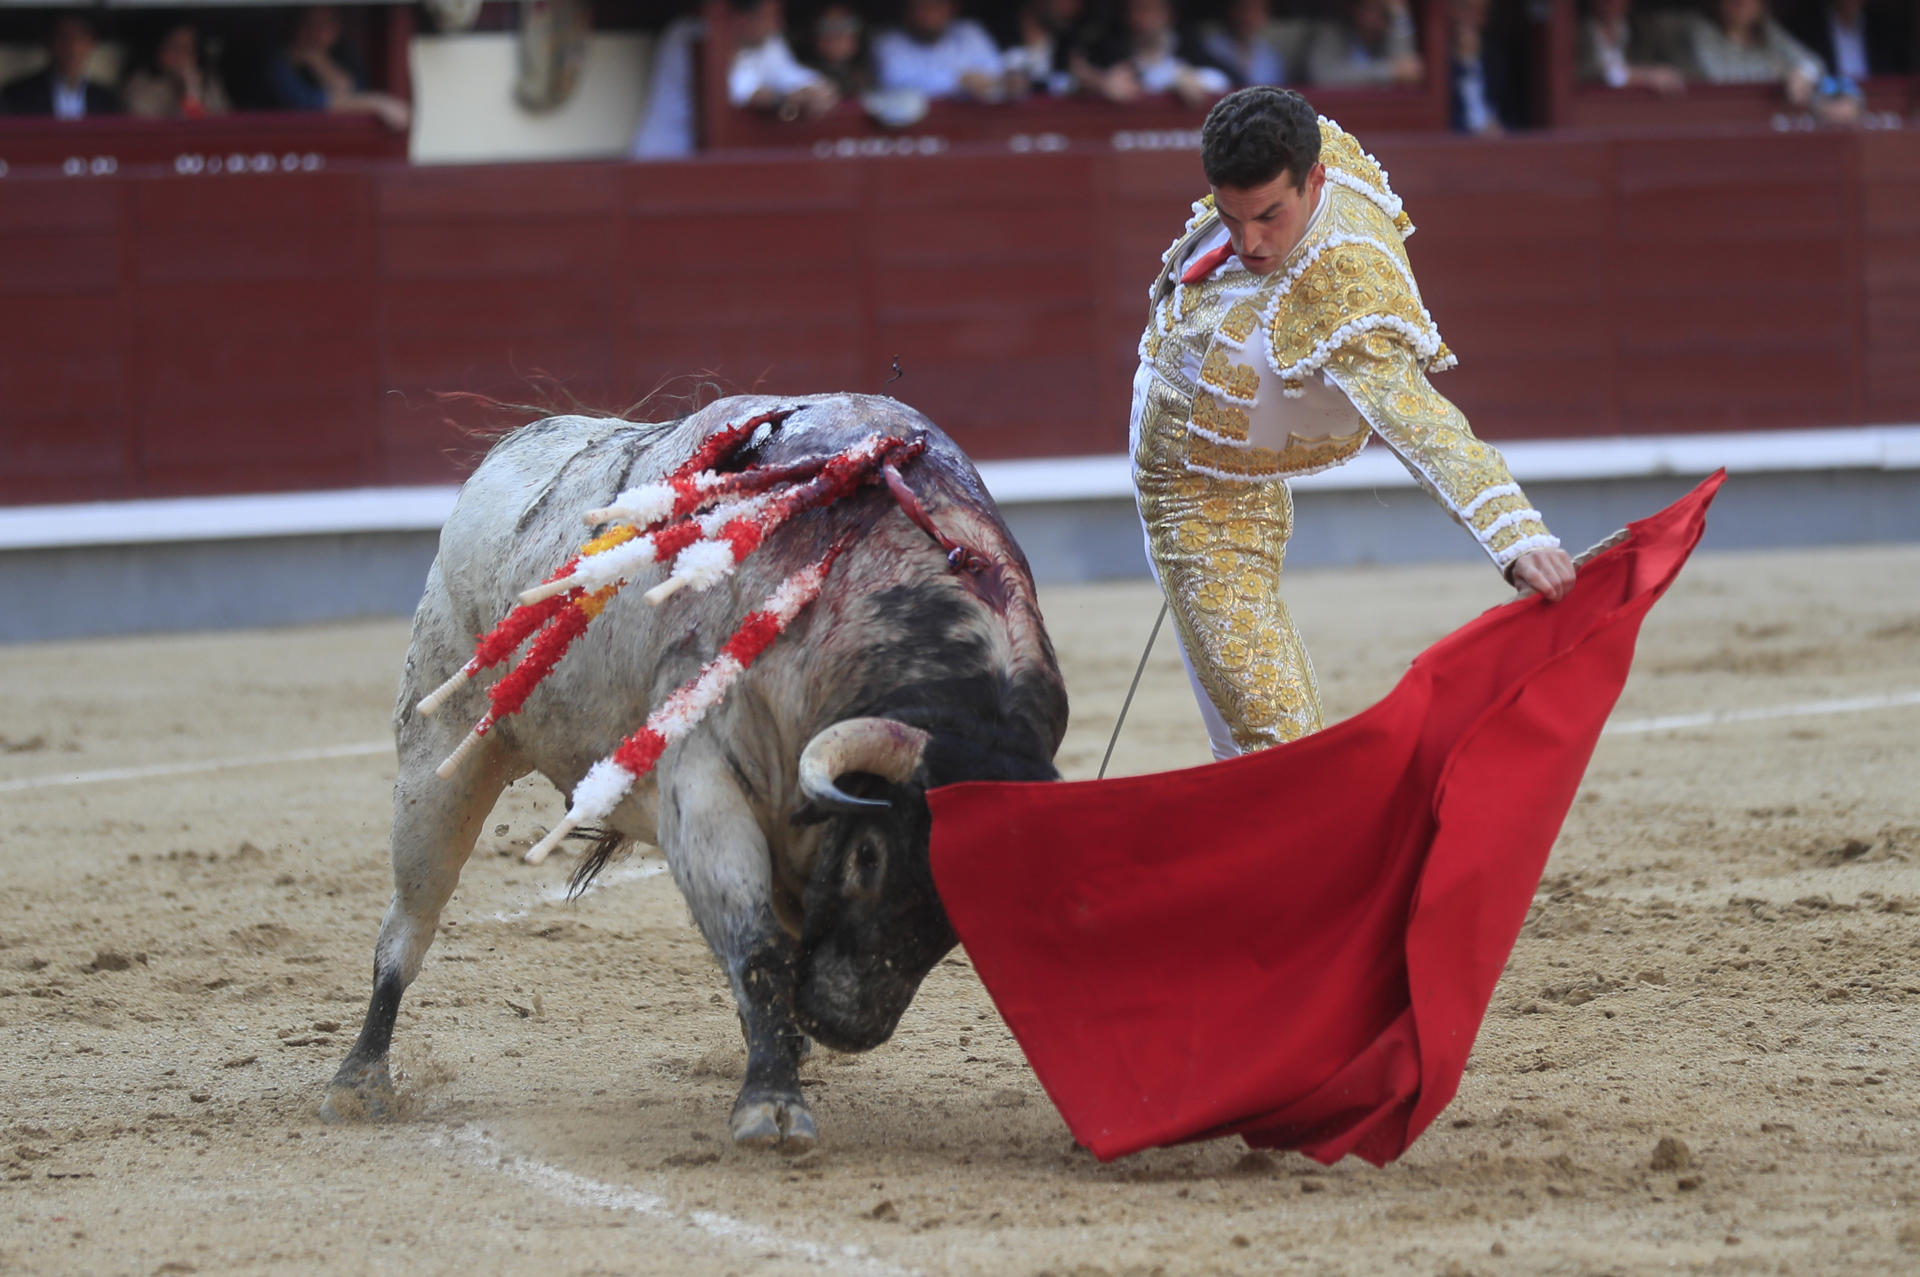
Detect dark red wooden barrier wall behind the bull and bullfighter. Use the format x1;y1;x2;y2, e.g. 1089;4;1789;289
0;131;1920;503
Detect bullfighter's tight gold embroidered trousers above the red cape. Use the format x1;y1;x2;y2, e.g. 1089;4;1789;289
1133;376;1321;753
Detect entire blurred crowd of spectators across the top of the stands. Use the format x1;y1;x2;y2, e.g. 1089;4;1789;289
0;0;1914;145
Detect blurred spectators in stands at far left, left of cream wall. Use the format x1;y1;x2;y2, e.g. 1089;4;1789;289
0;4;411;129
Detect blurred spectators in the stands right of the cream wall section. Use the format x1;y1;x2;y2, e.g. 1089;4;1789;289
702;0;1912;134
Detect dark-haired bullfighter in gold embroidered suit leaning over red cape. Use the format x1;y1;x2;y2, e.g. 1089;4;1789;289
1129;86;1574;759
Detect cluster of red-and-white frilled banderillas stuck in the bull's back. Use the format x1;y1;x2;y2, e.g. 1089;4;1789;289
419;409;967;864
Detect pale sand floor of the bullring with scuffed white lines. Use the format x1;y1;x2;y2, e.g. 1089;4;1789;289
0;547;1920;1277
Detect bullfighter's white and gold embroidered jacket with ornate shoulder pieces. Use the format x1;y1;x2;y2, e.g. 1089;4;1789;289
1133;117;1559;570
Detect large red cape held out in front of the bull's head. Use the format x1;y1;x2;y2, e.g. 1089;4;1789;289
929;474;1724;1166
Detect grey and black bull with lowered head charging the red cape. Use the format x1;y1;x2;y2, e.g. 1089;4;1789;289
323;396;1068;1146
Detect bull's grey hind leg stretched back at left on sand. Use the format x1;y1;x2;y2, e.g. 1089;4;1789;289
321;711;524;1121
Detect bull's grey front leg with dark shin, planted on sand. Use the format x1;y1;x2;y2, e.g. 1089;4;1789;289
660;741;818;1148
